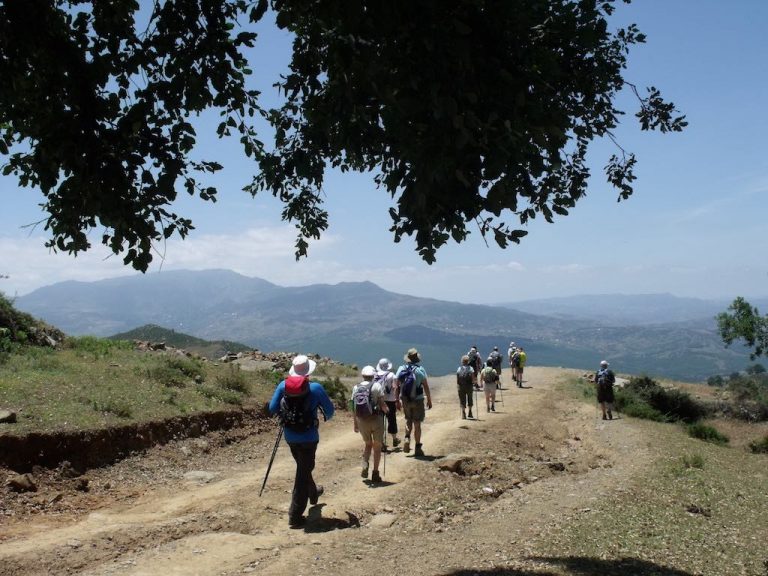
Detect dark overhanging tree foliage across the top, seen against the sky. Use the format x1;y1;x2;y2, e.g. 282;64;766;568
0;0;686;270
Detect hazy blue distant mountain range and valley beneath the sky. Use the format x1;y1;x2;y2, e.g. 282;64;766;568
15;270;760;381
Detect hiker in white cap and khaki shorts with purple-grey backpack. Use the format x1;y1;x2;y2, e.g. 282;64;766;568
352;366;388;482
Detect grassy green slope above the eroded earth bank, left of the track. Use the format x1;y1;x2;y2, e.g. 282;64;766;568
0;295;354;434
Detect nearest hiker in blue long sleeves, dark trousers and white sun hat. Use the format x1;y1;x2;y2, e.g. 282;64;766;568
269;354;333;528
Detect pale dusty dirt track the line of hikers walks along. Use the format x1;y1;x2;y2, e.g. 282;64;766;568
0;367;651;576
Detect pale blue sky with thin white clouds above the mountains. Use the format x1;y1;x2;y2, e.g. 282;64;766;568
0;0;768;303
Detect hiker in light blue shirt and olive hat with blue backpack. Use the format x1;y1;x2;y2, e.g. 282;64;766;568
395;348;432;456
